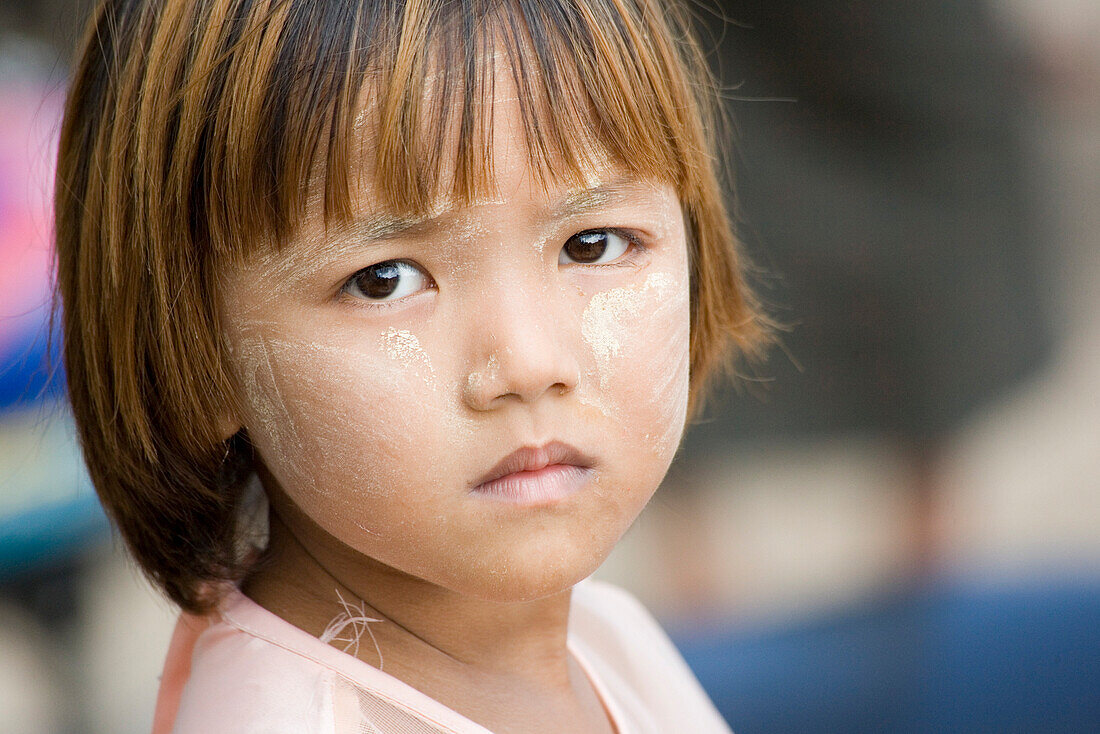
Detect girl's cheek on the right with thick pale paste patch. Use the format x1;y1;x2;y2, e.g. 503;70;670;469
582;270;691;461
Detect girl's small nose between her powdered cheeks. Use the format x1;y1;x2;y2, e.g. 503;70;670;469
463;283;581;410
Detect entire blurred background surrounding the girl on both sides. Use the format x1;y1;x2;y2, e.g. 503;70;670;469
0;0;1100;734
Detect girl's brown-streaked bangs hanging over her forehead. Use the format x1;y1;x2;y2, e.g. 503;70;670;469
162;0;713;255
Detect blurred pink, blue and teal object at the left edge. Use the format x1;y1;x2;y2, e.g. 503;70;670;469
0;53;108;581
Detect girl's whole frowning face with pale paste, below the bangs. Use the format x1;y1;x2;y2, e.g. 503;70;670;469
222;90;690;601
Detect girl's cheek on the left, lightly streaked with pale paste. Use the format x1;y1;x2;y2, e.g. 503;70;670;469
229;329;448;525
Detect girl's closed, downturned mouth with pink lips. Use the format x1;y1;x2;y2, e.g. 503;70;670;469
471;441;595;505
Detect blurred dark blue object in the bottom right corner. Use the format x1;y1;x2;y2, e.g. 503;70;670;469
677;577;1100;734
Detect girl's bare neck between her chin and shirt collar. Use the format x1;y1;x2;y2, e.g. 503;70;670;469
243;504;579;693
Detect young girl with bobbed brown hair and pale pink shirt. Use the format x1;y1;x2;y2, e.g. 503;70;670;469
56;0;760;734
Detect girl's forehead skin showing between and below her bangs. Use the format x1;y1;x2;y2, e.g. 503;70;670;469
278;63;677;257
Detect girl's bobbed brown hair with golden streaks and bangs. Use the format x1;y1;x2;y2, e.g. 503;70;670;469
55;0;765;612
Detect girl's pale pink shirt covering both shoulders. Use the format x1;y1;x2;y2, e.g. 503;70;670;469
153;580;729;734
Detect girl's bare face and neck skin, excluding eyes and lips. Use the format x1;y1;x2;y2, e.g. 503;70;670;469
220;71;689;732
